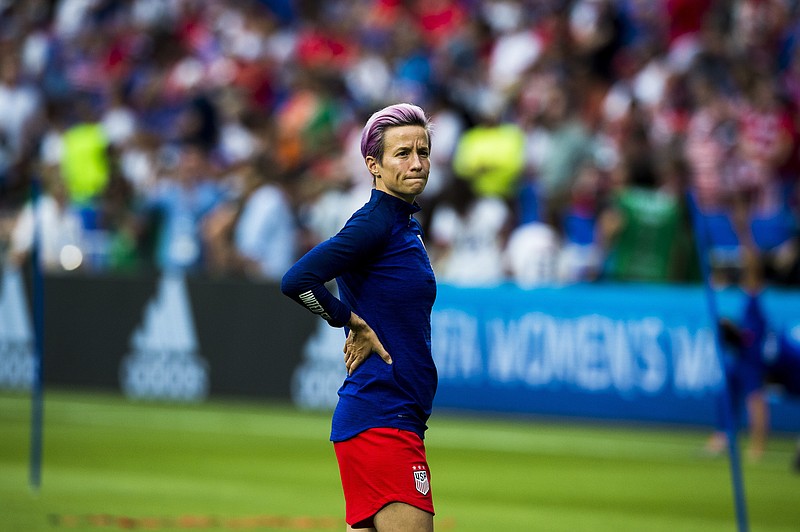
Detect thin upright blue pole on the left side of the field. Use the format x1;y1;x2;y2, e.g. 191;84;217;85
28;177;44;492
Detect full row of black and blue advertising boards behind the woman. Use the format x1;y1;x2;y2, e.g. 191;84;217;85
0;268;800;432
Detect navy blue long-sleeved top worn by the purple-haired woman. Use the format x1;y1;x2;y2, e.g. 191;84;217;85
281;190;437;442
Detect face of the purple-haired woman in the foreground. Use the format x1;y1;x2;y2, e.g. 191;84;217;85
365;126;431;203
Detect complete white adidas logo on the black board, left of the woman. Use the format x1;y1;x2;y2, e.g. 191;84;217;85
120;274;209;401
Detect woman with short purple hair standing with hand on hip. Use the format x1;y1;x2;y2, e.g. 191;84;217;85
281;104;437;532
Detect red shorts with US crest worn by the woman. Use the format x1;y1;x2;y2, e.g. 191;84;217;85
333;428;434;528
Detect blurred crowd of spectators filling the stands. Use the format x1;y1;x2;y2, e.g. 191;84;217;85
0;0;800;286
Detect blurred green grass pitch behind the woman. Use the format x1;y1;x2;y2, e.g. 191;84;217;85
0;390;800;532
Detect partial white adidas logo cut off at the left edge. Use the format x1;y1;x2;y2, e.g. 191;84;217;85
0;267;36;391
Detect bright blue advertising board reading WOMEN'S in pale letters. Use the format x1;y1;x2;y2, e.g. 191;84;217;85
432;284;800;431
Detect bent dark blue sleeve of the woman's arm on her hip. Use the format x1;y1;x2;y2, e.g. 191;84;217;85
281;210;390;327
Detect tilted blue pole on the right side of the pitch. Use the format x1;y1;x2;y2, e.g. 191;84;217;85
687;192;748;532
